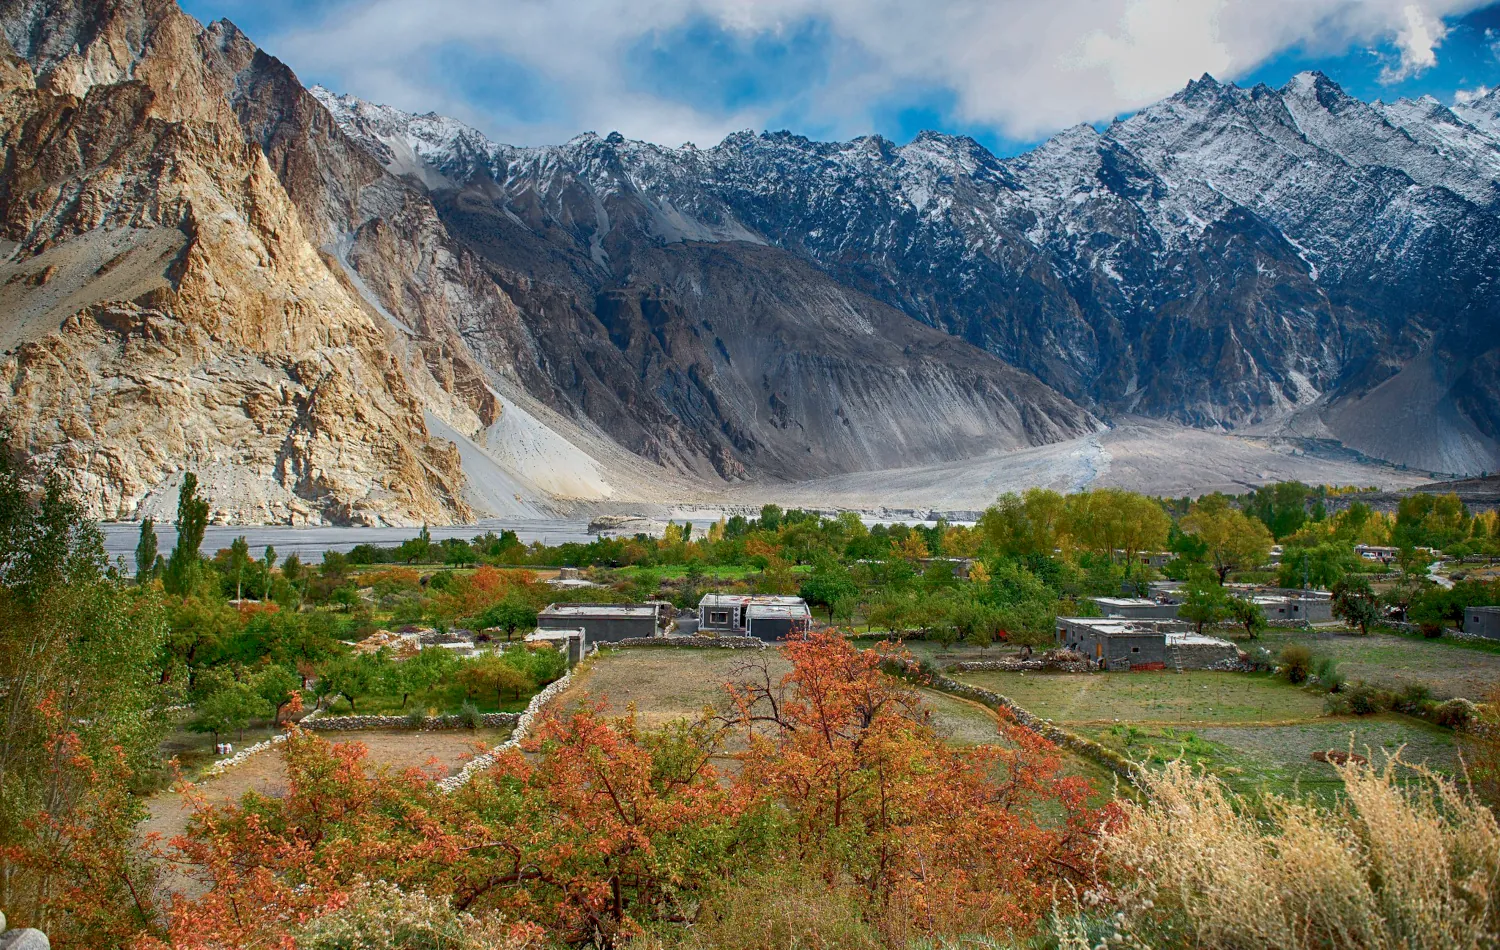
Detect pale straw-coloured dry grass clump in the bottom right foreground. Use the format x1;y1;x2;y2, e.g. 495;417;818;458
1104;758;1500;950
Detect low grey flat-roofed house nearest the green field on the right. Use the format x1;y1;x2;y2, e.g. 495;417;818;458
1058;617;1239;671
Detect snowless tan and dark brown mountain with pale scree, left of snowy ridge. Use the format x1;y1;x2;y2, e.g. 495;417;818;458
0;0;1098;524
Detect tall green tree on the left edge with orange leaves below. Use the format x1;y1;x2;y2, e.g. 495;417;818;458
0;459;171;947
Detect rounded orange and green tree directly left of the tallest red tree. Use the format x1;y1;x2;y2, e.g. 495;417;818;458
456;705;758;947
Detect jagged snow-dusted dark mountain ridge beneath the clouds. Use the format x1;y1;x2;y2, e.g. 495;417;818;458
315;74;1500;471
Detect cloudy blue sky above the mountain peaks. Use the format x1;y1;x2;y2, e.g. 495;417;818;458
183;0;1500;155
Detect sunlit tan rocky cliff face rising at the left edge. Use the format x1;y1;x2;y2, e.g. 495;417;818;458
0;2;510;524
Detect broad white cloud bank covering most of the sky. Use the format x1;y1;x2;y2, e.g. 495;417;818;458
267;0;1490;144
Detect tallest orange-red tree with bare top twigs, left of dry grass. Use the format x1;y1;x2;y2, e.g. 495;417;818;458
720;633;1118;945
